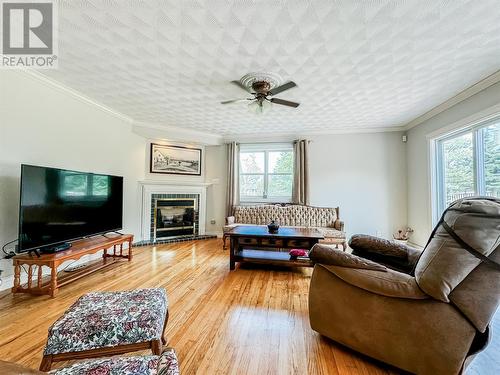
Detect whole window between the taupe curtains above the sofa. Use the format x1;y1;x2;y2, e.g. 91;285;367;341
240;144;293;202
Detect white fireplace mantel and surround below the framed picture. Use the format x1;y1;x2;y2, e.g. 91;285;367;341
139;180;212;241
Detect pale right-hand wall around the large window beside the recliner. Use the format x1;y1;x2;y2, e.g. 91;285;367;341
407;83;500;246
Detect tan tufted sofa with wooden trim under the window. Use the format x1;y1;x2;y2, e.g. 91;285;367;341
223;204;347;250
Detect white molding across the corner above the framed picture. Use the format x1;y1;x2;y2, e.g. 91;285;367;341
132;122;223;146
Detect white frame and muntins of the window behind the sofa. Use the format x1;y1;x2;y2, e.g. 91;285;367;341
238;143;295;204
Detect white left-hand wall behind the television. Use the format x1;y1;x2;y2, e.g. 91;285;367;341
0;70;146;282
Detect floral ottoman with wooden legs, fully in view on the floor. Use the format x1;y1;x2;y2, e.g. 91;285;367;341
40;288;168;371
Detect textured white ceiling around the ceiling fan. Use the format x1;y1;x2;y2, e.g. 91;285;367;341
43;0;500;135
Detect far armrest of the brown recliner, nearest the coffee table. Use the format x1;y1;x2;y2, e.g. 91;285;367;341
349;234;421;273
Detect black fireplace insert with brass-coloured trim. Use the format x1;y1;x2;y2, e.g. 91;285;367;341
154;198;196;240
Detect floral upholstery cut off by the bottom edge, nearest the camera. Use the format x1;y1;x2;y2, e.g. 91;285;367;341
50;348;180;375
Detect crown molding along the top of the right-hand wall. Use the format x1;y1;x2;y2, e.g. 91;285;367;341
402;70;500;130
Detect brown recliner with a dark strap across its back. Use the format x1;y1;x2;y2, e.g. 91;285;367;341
309;197;500;375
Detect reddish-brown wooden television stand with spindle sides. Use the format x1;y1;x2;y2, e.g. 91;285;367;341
12;234;134;297
